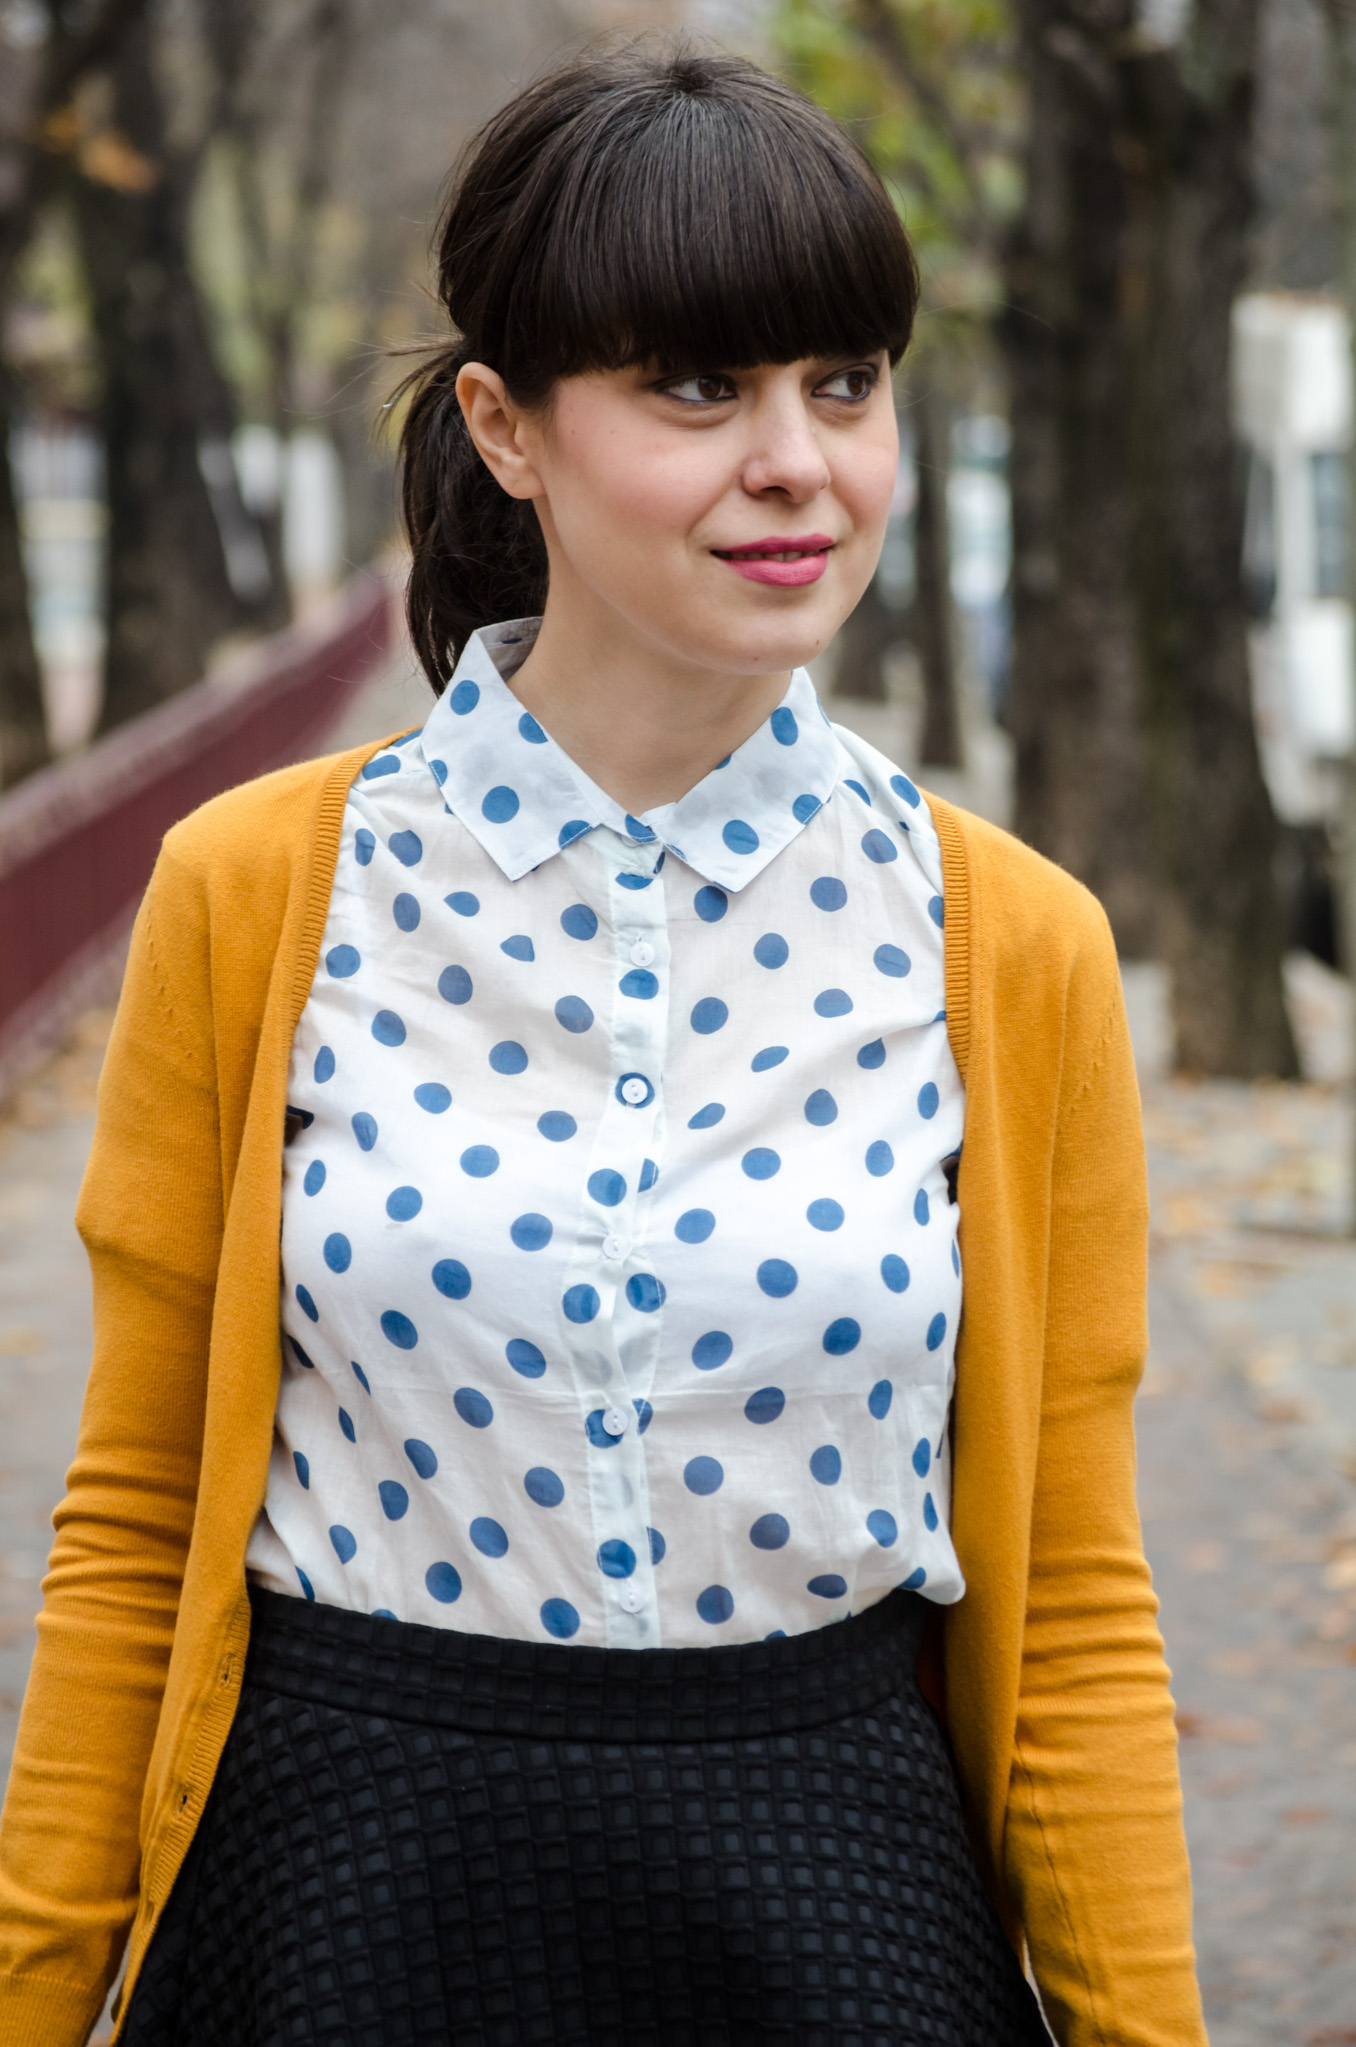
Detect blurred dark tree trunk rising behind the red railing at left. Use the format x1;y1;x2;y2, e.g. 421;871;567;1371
74;23;242;731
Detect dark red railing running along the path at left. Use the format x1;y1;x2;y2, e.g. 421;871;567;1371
0;573;391;1099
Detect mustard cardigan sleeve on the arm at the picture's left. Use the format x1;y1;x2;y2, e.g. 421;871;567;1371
0;854;223;2047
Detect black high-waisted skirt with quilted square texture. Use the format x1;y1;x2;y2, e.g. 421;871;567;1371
123;1591;1049;2047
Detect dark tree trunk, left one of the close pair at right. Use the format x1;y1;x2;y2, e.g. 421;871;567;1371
1000;0;1155;958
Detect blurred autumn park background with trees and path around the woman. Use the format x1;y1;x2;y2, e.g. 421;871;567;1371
0;0;1356;2047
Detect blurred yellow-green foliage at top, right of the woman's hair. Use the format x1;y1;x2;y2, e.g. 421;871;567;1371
770;0;1024;328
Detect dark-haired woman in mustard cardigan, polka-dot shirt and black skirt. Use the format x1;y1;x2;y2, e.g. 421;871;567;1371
0;36;1204;2047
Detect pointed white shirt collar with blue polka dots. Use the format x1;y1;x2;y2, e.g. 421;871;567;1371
420;618;838;892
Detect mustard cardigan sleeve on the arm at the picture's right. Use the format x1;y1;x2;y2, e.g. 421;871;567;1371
1004;962;1204;2047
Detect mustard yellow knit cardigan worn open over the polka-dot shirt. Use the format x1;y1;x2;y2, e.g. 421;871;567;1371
0;747;1204;2047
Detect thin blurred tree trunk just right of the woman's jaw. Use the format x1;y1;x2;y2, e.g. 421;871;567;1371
912;375;965;768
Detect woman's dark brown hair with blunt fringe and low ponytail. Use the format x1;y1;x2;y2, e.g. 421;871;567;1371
401;43;918;690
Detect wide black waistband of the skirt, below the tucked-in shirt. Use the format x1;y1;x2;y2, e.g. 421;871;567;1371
246;1586;926;1742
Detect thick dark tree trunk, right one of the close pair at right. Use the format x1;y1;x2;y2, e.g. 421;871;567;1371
1125;0;1299;1077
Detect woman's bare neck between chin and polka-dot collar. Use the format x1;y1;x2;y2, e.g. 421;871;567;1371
510;604;791;817
